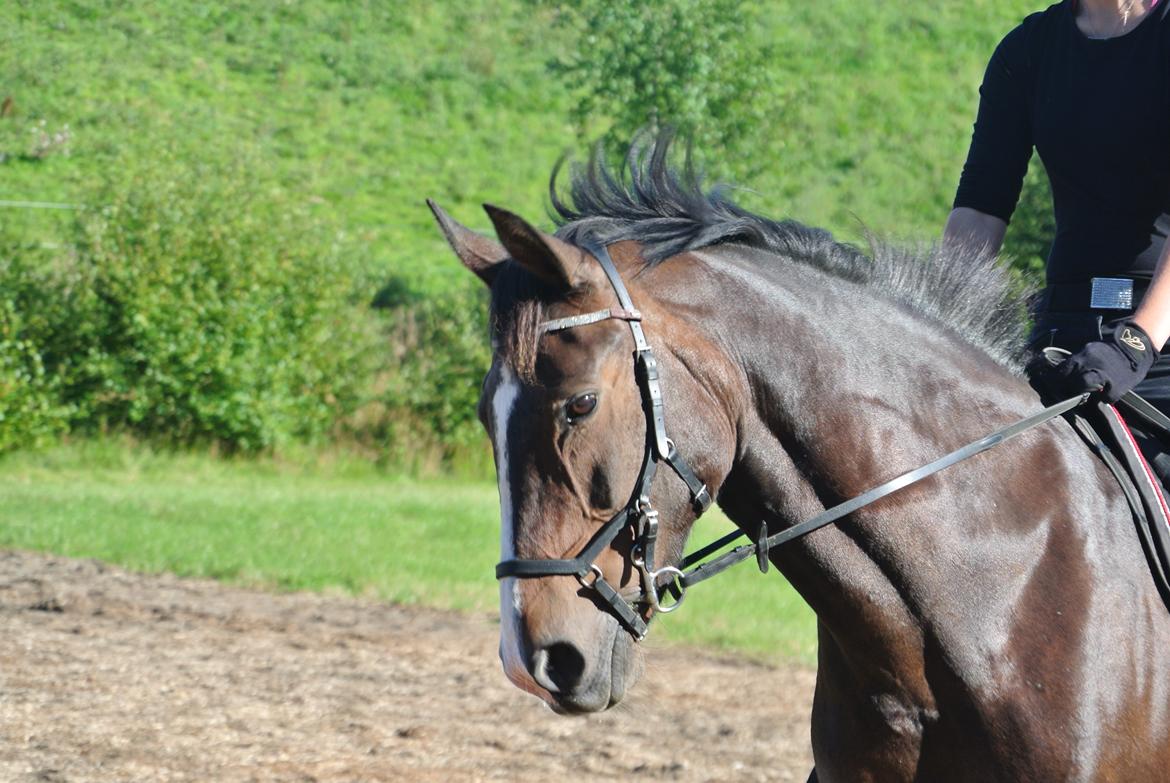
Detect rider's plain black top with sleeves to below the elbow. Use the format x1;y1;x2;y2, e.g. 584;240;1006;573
955;0;1170;283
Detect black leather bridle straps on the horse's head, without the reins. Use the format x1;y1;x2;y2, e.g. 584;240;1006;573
496;242;711;641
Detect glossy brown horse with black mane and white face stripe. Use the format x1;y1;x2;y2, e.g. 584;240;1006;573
429;138;1170;783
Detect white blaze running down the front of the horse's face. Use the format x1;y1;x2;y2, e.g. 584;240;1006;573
491;366;528;681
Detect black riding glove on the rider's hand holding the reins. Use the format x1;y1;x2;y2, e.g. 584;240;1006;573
1032;321;1158;403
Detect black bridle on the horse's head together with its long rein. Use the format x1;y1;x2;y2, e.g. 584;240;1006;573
496;240;1095;641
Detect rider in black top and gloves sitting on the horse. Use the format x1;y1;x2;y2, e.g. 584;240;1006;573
943;0;1170;483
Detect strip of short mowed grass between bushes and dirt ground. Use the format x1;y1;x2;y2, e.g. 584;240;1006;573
0;447;814;661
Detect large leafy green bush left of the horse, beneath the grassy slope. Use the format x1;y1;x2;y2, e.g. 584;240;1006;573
0;154;373;451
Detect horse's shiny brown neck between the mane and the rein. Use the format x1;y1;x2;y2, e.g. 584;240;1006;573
683;242;1038;500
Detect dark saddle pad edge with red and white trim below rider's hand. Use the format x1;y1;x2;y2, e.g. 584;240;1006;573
1086;403;1170;605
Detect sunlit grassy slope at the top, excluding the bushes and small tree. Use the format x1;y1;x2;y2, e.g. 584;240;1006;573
0;0;1047;290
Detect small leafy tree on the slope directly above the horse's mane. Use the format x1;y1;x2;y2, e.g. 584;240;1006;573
538;0;789;176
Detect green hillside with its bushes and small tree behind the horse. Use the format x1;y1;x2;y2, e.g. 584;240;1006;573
0;0;1041;459
